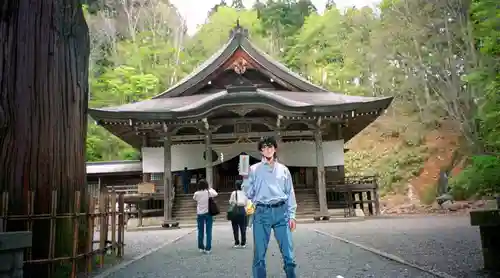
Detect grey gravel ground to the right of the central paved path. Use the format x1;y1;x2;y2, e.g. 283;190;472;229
308;216;488;278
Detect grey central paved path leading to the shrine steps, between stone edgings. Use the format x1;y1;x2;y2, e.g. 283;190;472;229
103;225;433;278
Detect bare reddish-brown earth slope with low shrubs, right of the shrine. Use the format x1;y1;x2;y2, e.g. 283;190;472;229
345;109;458;210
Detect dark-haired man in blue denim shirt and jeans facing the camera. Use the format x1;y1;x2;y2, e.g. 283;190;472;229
243;137;297;278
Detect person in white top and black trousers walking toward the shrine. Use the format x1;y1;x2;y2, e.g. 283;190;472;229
229;180;248;248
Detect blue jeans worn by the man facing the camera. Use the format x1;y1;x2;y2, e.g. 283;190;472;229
252;204;296;278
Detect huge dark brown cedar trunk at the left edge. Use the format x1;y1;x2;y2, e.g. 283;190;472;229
0;0;89;277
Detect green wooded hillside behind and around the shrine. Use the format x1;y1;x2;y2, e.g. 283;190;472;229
84;0;500;203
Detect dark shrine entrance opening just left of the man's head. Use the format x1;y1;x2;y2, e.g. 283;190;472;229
214;153;259;192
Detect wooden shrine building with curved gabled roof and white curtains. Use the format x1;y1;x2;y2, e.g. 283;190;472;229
89;24;392;226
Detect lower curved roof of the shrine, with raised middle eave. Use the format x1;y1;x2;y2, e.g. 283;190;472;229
90;89;392;120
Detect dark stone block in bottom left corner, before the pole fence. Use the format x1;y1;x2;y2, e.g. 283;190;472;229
0;232;31;278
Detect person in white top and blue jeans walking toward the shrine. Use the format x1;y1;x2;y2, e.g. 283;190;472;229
193;180;218;254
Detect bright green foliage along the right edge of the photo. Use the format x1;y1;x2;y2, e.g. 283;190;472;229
451;0;500;199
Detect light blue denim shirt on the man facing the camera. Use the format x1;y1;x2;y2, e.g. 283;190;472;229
242;161;297;219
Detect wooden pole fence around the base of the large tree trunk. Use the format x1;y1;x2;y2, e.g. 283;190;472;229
0;190;125;278
